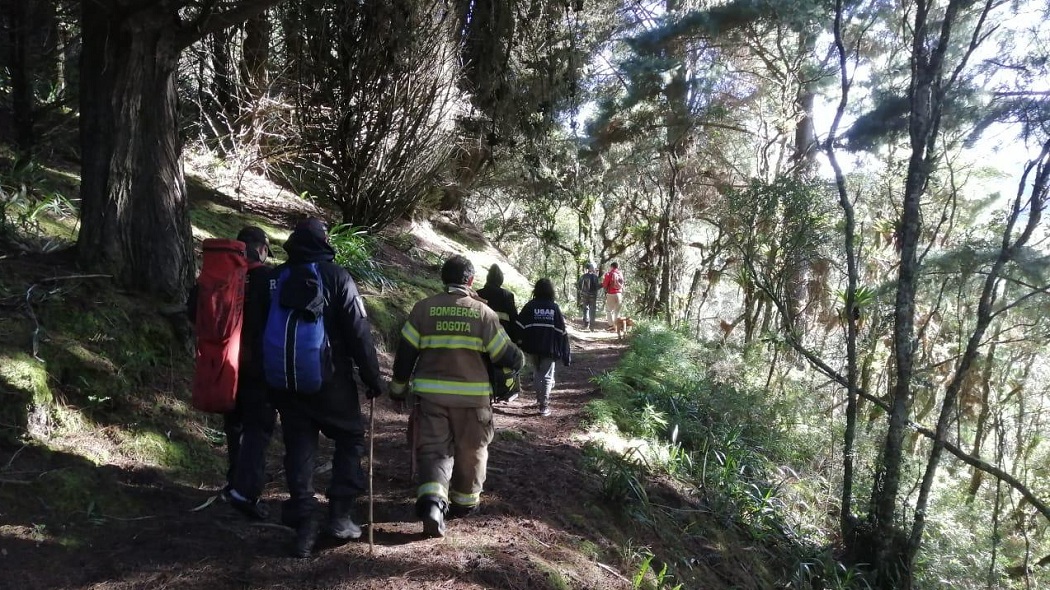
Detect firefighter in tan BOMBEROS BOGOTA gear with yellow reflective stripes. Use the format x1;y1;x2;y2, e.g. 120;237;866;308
390;255;525;536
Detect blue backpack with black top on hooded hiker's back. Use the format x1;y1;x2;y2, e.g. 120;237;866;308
263;262;335;394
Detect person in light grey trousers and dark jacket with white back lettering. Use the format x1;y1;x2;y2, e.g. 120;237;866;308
518;278;572;416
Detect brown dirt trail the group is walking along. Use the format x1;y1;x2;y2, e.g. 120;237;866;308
6;323;630;589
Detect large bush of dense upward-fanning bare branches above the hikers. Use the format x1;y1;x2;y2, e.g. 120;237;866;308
286;0;464;229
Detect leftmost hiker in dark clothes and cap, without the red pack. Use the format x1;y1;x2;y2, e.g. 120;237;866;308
186;226;276;521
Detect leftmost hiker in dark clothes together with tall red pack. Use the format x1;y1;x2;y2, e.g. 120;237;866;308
187;226;276;520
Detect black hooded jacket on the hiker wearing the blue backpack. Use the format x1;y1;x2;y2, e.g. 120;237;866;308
267;230;382;427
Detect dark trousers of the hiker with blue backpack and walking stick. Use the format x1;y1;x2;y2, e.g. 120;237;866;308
277;394;368;523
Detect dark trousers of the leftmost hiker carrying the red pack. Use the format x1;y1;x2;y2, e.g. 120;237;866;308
223;381;276;501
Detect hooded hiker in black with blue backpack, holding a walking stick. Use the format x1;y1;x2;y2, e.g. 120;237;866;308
264;218;383;557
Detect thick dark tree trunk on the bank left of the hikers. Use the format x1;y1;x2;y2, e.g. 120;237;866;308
77;0;193;300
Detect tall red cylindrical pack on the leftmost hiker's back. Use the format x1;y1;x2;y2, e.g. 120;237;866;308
191;239;248;414
